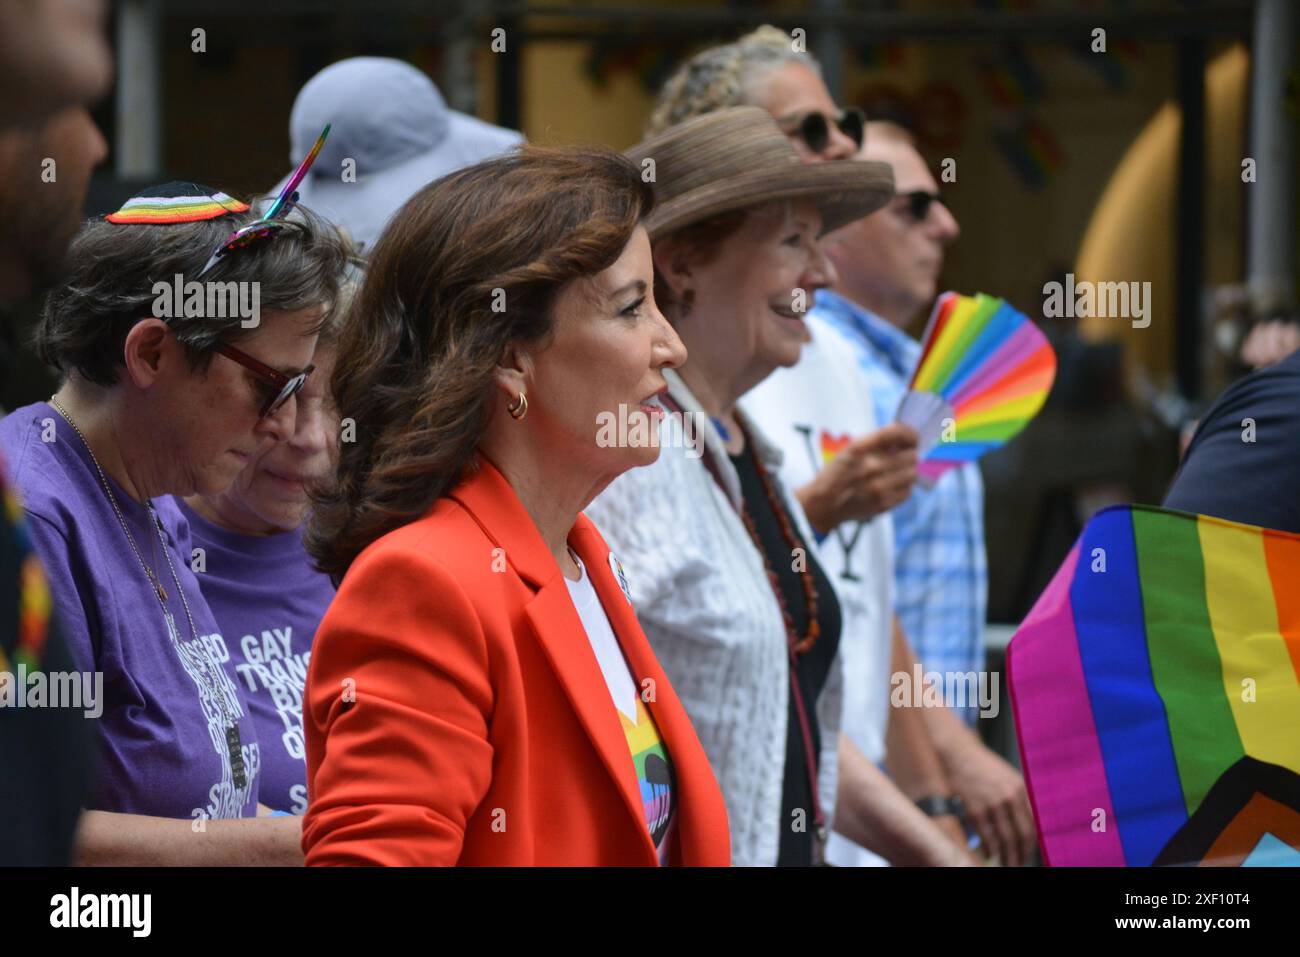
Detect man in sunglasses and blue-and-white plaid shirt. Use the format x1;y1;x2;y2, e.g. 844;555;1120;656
813;121;1036;865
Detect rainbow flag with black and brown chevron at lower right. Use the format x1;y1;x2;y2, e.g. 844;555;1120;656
1008;506;1300;866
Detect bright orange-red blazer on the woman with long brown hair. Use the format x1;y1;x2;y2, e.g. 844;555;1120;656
303;458;731;866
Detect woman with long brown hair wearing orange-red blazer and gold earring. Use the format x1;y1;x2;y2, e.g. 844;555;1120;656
303;148;729;866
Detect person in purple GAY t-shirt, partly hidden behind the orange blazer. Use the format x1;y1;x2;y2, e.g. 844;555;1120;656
177;302;345;814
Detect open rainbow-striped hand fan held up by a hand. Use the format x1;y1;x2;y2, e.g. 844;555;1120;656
897;293;1056;485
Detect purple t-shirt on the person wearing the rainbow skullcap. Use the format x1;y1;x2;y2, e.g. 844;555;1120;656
0;402;261;819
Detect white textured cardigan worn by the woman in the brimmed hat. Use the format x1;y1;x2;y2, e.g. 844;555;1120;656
586;371;844;866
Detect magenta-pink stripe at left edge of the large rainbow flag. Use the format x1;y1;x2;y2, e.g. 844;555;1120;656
1006;544;1126;867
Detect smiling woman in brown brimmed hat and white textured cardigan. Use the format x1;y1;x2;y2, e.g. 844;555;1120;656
590;107;967;865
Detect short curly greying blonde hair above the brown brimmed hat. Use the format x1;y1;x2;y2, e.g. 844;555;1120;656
646;25;822;137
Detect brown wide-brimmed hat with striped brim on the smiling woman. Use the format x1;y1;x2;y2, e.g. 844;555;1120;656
625;107;894;242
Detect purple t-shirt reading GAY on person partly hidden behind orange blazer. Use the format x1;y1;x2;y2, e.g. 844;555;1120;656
173;499;334;814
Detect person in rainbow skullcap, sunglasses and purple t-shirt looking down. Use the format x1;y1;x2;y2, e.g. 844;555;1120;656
0;183;346;865
